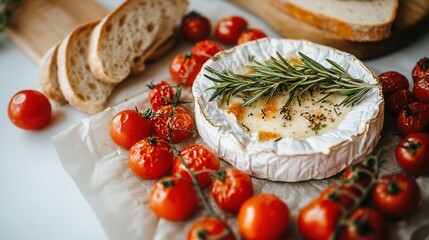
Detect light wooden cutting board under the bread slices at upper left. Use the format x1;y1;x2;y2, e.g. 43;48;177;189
5;0;109;64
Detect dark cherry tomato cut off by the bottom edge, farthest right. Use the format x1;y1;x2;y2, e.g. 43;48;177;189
338;208;389;240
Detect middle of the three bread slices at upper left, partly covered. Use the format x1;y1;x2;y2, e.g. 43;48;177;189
57;22;116;114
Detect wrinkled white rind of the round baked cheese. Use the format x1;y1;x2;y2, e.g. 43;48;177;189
193;38;384;182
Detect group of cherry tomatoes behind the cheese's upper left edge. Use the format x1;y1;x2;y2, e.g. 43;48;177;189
169;11;267;86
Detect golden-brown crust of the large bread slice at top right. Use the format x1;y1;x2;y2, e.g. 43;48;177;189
272;0;399;42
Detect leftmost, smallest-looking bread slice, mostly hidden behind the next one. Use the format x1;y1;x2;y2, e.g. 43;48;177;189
39;44;67;105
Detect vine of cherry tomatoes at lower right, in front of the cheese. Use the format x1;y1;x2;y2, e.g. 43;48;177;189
297;156;420;240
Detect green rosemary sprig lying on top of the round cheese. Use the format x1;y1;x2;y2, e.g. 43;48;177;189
204;52;377;107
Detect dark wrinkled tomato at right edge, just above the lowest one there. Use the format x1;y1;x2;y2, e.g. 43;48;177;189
396;102;429;137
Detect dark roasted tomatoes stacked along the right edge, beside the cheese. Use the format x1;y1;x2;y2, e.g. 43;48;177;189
379;57;429;175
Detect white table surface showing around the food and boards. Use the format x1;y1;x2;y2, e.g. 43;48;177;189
0;0;429;240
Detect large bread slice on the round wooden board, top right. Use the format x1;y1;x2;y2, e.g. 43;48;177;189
269;0;398;42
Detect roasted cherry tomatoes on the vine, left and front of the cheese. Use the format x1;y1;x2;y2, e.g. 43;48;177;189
110;81;289;239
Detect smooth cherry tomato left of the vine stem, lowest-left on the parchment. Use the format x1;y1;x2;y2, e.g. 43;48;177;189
149;176;198;221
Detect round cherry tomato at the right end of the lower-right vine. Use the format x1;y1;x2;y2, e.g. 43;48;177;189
372;174;420;219
